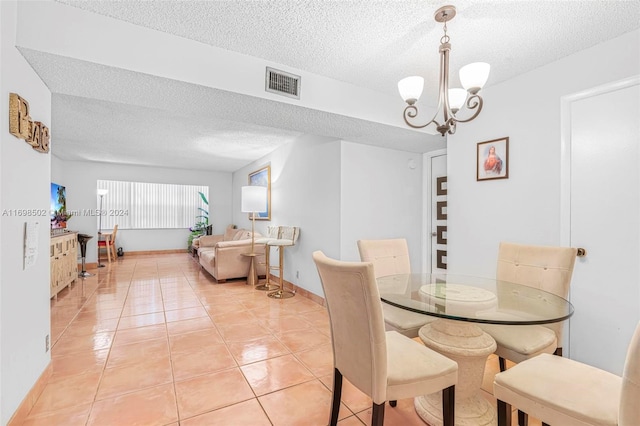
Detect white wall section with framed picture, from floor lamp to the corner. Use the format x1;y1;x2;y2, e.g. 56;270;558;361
233;137;341;296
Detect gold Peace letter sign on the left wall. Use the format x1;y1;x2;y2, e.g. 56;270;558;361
9;93;50;152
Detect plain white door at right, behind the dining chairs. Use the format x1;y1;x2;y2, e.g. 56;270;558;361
562;78;640;375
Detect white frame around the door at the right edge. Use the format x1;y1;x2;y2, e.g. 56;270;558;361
560;75;640;357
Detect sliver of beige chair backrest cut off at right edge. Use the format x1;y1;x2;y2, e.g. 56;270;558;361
618;323;640;426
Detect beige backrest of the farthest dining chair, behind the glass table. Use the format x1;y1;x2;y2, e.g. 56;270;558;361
358;238;411;278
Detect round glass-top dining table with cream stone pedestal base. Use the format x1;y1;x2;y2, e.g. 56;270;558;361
377;274;573;426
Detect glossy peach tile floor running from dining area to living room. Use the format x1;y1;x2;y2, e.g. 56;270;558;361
24;254;540;426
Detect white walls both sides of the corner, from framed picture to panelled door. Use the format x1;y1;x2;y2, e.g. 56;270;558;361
233;137;422;297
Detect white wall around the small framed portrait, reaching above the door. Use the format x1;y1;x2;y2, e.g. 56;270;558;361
447;31;640;278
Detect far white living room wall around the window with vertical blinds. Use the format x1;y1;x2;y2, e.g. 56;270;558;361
51;158;232;263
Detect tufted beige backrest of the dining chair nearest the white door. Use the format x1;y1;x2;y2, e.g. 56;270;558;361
496;242;577;346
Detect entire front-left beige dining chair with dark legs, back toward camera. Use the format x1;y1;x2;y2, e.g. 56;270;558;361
313;251;458;426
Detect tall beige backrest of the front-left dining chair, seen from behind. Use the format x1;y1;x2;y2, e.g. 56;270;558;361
313;251;387;404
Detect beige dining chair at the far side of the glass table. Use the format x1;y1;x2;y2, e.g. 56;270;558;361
358;238;436;338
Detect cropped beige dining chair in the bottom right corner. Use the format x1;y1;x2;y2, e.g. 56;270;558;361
493;324;640;426
